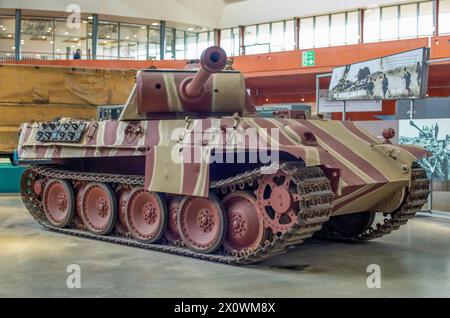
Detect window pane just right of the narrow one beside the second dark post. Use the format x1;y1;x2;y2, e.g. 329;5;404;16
119;24;147;60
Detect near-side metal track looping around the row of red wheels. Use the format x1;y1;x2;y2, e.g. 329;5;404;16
21;163;334;265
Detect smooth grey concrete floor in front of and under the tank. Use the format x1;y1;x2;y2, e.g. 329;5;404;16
0;196;450;297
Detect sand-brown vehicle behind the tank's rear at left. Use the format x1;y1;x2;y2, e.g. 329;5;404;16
0;64;136;156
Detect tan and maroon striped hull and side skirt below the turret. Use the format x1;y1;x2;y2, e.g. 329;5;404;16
19;117;428;214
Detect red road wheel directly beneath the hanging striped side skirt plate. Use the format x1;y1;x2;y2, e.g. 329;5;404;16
178;193;227;254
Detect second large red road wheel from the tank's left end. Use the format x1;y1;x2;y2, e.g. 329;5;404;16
81;182;117;235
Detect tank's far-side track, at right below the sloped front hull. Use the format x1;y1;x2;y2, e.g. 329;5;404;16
315;163;430;243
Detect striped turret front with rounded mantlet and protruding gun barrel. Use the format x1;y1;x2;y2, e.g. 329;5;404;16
136;46;254;114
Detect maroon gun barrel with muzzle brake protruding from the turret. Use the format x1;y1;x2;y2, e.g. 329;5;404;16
182;46;227;98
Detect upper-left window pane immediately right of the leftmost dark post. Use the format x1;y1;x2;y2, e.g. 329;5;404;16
21;18;53;59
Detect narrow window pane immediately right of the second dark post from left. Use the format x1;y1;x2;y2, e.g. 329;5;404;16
97;22;119;60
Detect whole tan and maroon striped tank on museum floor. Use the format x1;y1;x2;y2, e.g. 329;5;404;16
19;47;429;264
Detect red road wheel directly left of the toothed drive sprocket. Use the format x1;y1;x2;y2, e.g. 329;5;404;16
222;191;267;253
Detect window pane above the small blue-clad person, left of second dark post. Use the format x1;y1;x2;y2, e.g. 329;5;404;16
55;20;90;59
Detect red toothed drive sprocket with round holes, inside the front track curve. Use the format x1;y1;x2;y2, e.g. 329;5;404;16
256;171;301;233
